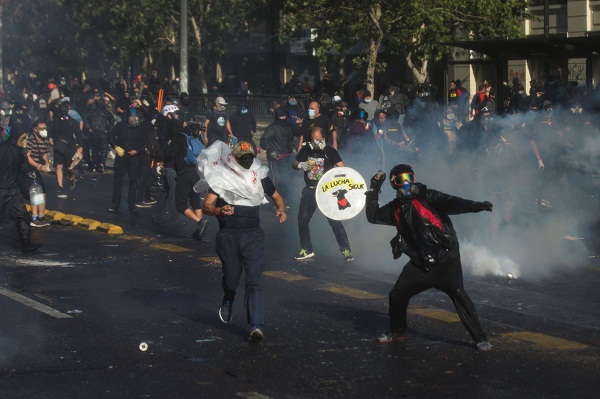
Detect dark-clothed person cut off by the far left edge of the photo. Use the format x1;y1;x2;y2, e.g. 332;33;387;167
0;124;41;252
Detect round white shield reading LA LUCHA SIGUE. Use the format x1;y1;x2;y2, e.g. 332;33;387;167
315;166;367;220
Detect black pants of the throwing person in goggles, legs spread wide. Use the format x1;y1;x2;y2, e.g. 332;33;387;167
389;257;487;342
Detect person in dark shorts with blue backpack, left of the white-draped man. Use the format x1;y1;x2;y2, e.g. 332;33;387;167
169;120;208;240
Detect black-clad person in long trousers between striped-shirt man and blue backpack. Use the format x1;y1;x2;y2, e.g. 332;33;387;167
108;111;146;213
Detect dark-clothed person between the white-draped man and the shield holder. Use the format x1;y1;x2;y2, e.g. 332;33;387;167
260;108;296;202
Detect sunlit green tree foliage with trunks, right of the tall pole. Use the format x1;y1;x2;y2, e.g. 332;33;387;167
282;0;527;92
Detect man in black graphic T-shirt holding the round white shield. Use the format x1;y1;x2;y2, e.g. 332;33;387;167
293;126;354;262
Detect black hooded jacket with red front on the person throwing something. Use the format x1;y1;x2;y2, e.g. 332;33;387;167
366;183;478;270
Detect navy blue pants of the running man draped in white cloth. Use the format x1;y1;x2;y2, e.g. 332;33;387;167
216;227;265;325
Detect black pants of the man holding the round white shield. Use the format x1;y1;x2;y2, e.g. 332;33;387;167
298;186;350;252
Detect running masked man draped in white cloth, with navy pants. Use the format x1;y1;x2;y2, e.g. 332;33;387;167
202;141;287;343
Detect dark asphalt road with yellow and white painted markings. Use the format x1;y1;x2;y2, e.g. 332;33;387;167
0;167;600;399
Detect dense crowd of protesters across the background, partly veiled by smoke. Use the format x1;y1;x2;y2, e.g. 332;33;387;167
0;70;598;244
